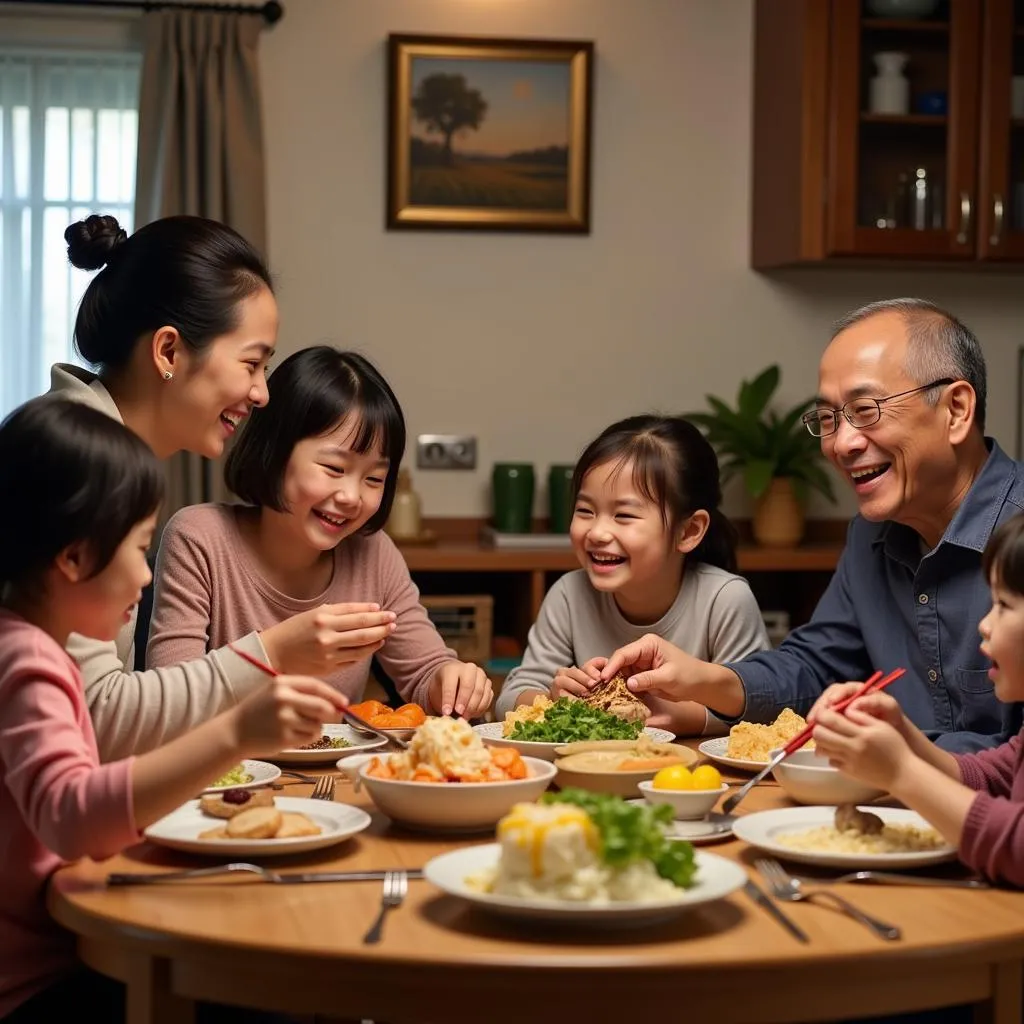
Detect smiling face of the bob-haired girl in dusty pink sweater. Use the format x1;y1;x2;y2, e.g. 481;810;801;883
270;416;389;551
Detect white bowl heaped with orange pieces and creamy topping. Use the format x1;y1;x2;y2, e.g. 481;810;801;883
352;718;555;831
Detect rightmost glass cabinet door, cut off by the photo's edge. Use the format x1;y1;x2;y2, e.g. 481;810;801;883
978;0;1024;260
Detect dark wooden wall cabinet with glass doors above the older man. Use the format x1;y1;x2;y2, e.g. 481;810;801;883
751;0;1024;268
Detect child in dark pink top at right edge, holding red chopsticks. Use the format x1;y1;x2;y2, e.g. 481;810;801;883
811;515;1024;887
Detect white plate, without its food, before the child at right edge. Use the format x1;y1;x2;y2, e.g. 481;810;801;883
732;805;956;871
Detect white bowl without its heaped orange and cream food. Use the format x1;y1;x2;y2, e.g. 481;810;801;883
338;755;555;831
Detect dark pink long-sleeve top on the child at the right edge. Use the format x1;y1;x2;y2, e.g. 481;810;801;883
956;730;1024;888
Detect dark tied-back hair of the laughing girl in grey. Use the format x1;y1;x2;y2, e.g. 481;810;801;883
572;416;737;572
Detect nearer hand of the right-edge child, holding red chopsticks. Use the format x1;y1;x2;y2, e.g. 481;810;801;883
814;693;916;791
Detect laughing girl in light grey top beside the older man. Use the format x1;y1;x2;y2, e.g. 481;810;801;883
497;415;768;734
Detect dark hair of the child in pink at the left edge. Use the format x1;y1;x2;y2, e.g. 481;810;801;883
0;395;164;589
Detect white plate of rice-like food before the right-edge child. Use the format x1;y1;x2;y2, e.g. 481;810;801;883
732;805;956;871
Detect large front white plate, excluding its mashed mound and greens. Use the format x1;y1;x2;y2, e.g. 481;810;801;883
423;843;746;927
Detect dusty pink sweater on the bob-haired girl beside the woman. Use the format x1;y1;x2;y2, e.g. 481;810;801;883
146;505;457;707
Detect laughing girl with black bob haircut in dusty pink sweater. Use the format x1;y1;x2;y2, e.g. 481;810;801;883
146;345;493;718
